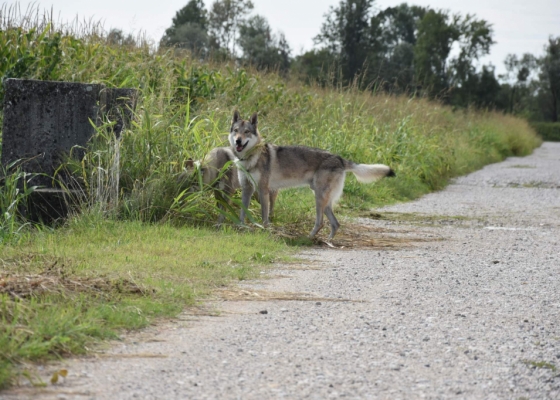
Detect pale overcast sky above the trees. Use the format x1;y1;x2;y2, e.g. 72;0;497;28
5;0;560;73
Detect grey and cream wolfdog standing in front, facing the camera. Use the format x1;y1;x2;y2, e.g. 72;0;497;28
229;110;395;240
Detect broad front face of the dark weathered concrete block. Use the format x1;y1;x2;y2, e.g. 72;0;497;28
2;79;103;188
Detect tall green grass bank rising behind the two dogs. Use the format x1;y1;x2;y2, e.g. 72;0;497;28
0;6;539;227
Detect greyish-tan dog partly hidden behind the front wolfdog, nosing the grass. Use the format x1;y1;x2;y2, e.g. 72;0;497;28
184;147;278;223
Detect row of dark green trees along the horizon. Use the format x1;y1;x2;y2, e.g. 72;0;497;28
147;0;560;122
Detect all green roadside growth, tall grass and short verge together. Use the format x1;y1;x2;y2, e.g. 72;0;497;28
0;6;540;388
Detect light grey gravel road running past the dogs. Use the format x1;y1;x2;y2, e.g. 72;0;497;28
5;143;560;399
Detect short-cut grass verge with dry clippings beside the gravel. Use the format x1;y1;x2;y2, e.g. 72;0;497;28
0;215;290;387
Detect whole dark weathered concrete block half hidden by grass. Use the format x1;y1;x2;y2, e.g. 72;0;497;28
1;79;137;222
